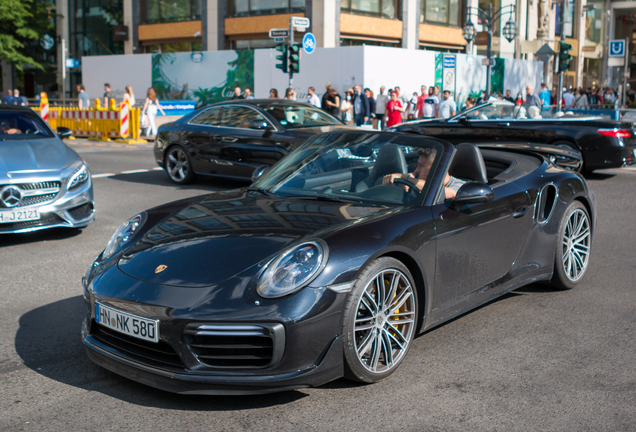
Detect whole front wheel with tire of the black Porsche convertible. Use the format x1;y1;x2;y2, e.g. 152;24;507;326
342;257;418;383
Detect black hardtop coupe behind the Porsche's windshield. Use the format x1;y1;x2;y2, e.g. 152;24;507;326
154;99;348;184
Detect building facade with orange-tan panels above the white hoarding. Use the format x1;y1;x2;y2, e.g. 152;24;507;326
37;0;604;97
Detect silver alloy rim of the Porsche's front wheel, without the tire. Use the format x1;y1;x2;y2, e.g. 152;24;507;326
353;269;416;373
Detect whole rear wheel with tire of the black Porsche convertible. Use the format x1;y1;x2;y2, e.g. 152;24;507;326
550;201;592;289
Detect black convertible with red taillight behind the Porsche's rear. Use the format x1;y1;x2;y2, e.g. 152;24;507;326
394;100;636;172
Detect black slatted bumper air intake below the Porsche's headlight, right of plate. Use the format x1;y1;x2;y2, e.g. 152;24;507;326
183;324;285;369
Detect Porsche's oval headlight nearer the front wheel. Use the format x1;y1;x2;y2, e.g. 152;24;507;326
257;241;326;298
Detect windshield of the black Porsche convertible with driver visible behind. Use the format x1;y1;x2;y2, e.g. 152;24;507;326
254;132;443;206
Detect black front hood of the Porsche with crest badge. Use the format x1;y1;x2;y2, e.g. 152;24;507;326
118;190;383;288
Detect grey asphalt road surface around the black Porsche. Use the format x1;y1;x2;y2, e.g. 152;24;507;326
0;142;636;432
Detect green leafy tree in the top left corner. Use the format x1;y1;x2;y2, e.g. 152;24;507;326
0;0;53;70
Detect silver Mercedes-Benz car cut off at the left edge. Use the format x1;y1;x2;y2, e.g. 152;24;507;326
0;106;95;234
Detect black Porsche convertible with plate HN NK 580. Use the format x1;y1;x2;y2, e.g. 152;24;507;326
81;131;596;394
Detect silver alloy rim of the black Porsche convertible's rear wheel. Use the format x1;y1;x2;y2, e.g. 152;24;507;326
562;209;590;282
